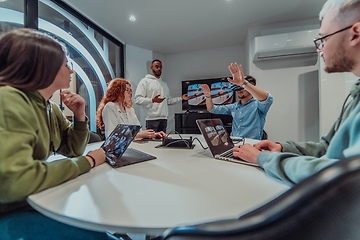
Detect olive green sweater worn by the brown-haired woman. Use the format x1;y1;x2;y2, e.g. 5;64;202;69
0;86;91;216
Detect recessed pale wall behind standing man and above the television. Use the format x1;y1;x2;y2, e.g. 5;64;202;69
125;45;245;133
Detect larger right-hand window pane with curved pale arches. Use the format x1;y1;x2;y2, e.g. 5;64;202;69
39;0;121;131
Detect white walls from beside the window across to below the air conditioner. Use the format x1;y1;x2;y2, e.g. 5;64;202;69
126;19;320;141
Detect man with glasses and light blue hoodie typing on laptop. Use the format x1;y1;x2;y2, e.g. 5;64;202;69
233;0;360;185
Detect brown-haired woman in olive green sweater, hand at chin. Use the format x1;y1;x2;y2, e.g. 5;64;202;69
0;29;107;239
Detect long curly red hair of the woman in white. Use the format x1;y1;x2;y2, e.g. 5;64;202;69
96;78;132;128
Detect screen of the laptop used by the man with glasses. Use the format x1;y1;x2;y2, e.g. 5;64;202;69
196;119;234;156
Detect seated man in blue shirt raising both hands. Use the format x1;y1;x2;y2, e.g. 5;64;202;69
200;63;273;140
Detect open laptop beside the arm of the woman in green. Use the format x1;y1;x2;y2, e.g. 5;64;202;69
101;124;156;168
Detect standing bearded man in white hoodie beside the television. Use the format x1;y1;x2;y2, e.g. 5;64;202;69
135;59;189;132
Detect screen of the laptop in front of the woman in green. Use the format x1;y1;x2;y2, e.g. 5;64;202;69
101;124;141;165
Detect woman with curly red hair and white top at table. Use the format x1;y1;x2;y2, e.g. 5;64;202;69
96;78;166;139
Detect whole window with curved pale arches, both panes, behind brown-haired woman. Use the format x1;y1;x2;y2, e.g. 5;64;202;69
0;0;123;131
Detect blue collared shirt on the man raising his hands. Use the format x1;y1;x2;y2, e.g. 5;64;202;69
210;93;273;140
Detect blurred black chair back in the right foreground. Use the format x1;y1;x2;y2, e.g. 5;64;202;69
157;156;360;240
